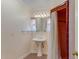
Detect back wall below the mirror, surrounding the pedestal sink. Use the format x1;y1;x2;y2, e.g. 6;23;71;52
31;32;49;55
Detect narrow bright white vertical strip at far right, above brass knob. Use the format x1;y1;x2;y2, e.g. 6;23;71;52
75;0;78;51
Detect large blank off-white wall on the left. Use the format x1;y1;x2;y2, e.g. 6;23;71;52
1;0;31;59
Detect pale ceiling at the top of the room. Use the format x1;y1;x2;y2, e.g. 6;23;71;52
22;0;66;9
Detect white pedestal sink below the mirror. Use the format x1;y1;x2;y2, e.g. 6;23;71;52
33;38;46;56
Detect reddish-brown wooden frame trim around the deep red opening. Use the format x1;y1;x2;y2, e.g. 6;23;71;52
50;1;69;58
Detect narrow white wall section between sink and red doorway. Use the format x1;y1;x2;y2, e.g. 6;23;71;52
48;12;60;59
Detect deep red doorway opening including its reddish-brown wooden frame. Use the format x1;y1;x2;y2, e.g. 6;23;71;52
51;1;69;59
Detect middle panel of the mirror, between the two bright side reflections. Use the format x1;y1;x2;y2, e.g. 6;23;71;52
36;18;47;32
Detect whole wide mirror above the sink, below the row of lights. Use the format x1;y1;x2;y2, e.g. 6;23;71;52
32;17;50;32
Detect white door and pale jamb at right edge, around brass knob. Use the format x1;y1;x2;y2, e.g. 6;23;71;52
69;0;78;59
